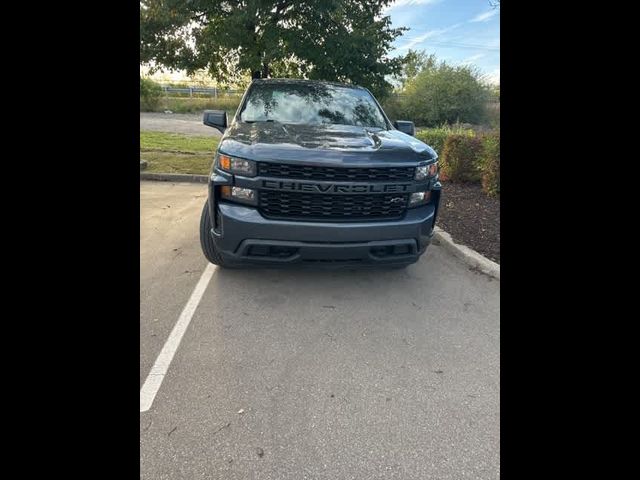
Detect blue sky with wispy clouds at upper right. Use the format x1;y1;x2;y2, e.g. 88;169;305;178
385;0;500;84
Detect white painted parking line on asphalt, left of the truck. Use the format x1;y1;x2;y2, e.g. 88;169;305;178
140;263;216;412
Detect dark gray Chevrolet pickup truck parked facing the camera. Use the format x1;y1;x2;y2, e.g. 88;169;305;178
200;79;441;267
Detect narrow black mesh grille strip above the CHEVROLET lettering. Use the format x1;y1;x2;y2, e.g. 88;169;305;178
258;162;415;182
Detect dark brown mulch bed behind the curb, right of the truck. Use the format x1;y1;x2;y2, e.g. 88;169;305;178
436;182;500;263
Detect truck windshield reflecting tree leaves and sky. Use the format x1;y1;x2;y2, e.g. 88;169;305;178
240;82;387;129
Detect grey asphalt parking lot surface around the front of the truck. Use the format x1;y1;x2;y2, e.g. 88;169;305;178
140;181;500;480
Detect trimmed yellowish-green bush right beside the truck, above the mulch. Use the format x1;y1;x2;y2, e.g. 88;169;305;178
440;134;482;182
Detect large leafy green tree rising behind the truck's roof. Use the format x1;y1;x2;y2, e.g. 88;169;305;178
140;0;406;95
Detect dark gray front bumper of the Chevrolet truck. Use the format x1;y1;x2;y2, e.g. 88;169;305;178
210;202;437;266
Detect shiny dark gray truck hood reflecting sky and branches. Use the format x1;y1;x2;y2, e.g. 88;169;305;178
219;122;437;166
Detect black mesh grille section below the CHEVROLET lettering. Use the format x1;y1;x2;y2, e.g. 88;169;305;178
259;190;409;221
